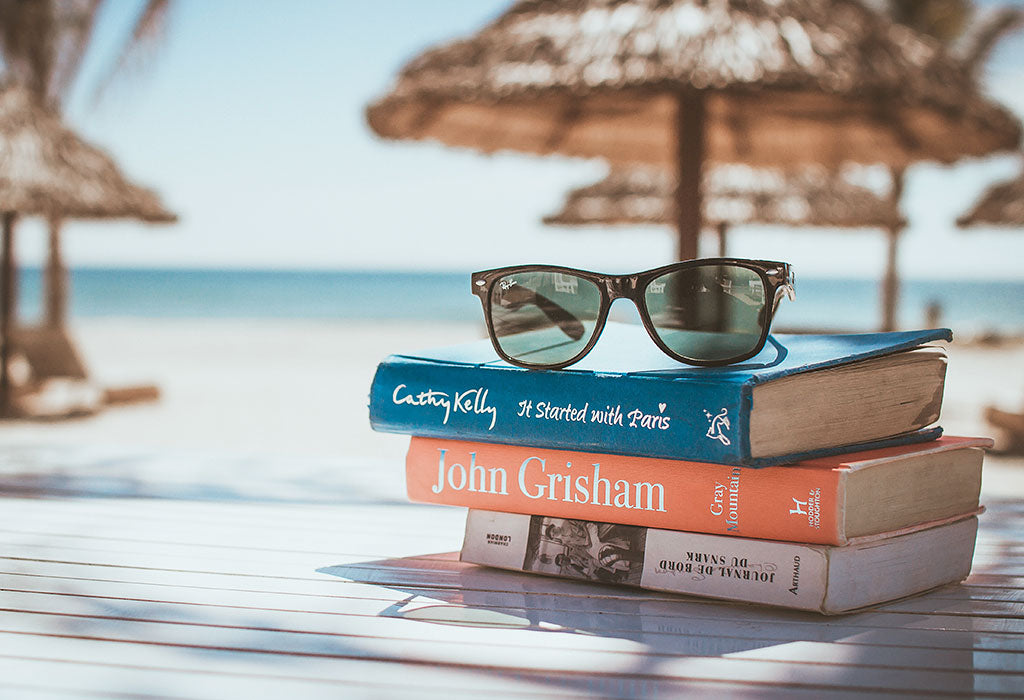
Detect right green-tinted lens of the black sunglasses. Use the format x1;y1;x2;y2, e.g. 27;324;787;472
644;265;767;362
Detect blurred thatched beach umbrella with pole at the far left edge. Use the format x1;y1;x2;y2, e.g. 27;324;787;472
0;87;176;410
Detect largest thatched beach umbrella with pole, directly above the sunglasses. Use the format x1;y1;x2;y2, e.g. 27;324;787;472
367;0;1020;259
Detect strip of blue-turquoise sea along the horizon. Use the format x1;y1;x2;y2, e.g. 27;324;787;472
18;267;1024;335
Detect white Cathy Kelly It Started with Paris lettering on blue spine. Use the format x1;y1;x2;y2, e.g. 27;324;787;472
391;384;672;430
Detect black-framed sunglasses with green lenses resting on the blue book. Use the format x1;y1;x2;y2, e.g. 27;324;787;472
472;258;795;369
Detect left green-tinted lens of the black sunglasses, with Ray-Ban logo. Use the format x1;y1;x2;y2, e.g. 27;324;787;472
490;271;601;366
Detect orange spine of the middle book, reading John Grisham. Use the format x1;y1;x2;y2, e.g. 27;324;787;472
406;437;845;544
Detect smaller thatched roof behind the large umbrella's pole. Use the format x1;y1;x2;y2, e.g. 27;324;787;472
544;165;905;228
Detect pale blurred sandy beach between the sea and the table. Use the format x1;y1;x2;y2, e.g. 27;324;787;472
0;319;1024;497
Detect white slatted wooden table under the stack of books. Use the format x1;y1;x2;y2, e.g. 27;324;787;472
0;448;1024;700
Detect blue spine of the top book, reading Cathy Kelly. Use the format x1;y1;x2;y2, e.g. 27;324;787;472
370;358;751;465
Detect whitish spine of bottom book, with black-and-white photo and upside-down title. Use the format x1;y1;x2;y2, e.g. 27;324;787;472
461;510;828;612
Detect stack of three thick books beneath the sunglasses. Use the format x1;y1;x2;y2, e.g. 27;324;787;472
370;323;989;614
